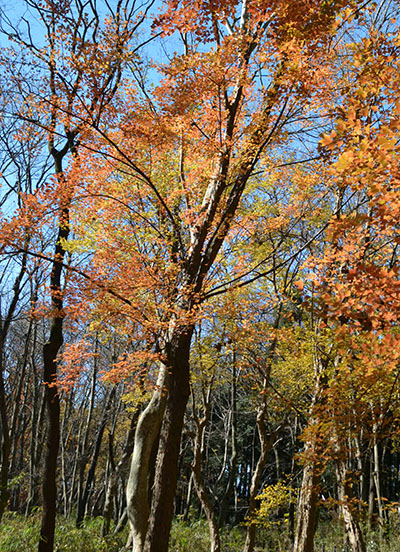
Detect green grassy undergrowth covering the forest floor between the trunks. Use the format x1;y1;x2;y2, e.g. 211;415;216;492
0;513;400;552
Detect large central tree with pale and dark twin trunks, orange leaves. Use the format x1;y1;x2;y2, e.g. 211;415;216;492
64;2;358;552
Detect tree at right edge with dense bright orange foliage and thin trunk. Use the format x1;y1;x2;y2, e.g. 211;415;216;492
296;3;399;552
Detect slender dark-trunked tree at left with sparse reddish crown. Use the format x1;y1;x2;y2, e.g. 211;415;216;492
3;0;147;552
